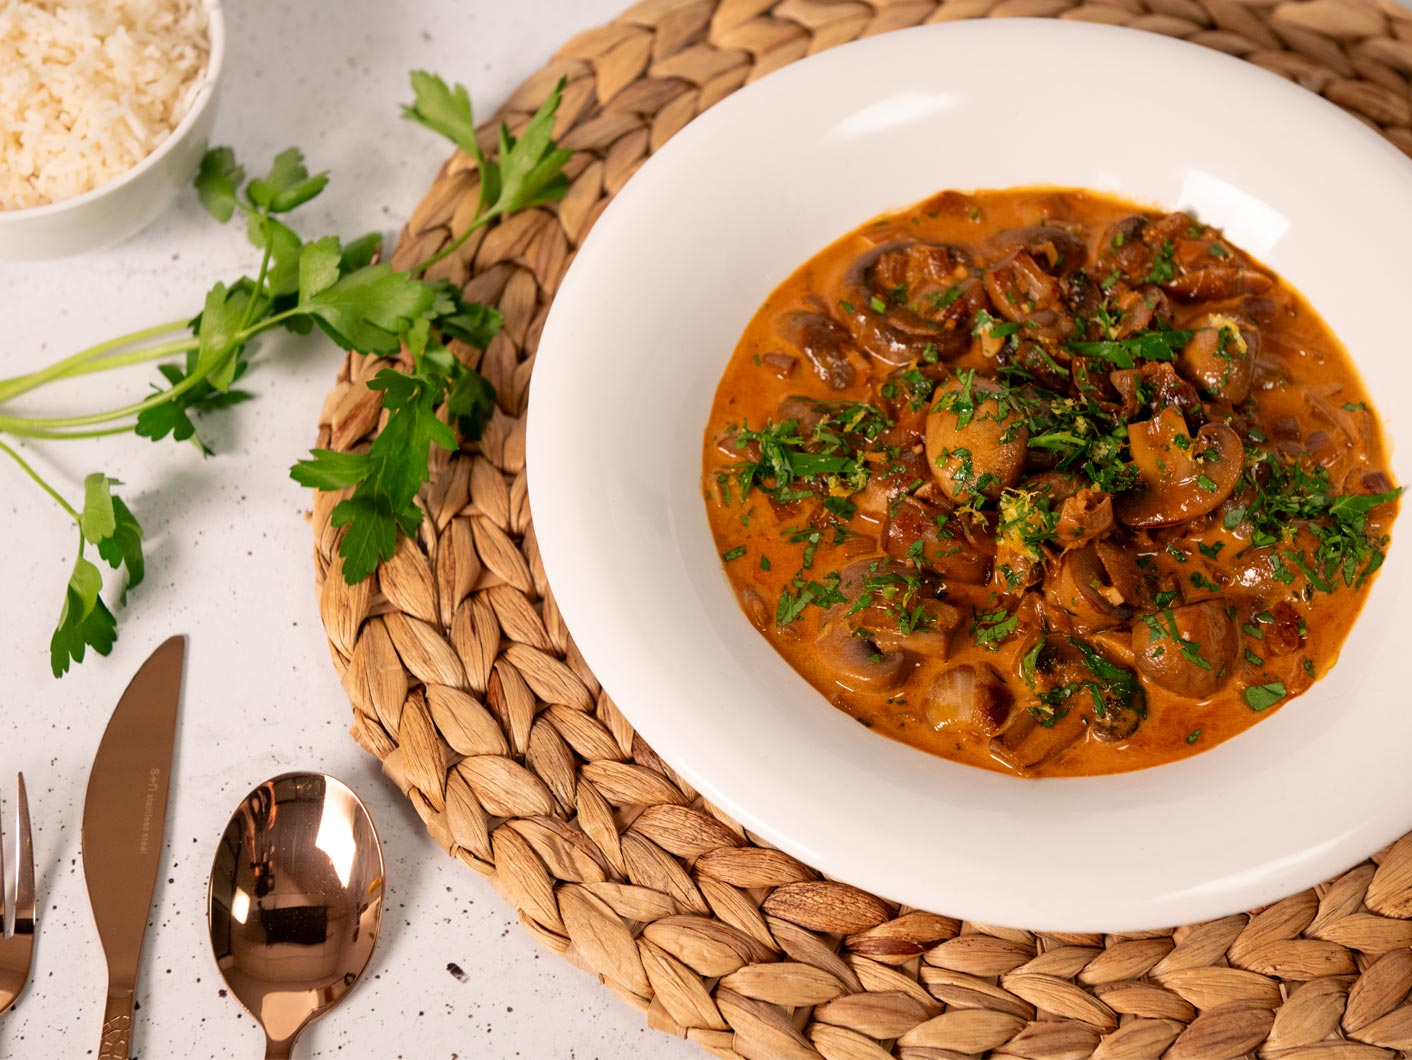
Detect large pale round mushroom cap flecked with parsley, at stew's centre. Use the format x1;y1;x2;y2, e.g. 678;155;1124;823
926;375;1029;502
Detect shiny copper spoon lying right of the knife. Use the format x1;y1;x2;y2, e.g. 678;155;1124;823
208;773;383;1060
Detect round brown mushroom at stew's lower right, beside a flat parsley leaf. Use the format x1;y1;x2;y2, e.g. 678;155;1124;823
1132;600;1240;700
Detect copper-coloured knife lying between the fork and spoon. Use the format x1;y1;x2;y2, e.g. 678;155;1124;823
82;637;186;1060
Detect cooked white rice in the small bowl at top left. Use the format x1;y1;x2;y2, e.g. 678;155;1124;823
0;0;210;210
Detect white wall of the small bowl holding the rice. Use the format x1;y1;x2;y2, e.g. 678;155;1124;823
0;0;226;261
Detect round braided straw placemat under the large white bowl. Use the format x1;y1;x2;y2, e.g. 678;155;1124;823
313;0;1412;1060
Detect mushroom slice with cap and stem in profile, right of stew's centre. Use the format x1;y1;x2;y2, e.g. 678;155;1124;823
1114;408;1245;529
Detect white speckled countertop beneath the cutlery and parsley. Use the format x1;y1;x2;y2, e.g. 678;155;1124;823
0;0;702;1060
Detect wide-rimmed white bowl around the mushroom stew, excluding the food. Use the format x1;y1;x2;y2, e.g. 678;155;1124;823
528;20;1412;932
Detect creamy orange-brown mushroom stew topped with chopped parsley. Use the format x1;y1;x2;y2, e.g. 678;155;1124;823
703;189;1401;776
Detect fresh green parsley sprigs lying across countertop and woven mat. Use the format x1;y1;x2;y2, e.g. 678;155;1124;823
0;72;569;676
